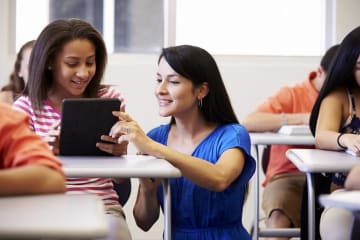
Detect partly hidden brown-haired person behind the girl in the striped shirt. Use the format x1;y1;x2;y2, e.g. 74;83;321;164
0;40;35;104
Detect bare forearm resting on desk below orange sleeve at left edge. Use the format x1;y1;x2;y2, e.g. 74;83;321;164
0;164;65;196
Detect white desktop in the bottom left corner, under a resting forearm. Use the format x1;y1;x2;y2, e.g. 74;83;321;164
0;194;109;239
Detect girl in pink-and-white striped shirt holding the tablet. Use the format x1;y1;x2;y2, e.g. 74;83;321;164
13;19;131;239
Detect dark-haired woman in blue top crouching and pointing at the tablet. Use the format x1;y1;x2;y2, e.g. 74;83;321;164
110;45;255;240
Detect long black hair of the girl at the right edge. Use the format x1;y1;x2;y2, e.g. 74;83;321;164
310;27;360;136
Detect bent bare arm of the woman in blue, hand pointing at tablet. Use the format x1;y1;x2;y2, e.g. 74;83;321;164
110;112;245;191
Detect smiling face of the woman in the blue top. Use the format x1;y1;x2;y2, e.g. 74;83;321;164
155;58;200;117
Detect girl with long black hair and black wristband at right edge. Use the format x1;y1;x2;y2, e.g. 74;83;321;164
310;27;360;240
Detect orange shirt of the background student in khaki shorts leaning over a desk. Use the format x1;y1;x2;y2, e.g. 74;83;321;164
257;73;318;186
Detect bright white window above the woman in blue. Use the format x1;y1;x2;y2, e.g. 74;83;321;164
176;0;325;56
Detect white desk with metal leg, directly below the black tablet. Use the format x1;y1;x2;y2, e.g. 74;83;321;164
59;155;181;240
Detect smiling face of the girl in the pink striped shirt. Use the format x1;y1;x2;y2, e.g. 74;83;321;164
50;39;96;98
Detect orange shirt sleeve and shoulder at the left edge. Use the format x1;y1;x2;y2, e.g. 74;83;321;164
0;103;64;174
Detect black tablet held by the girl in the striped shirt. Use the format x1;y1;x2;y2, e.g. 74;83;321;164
59;98;121;156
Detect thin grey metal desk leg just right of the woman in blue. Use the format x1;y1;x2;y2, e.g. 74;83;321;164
253;144;260;240
